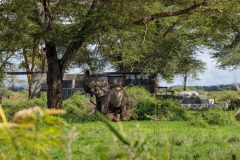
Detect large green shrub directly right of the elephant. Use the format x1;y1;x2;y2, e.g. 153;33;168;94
126;86;186;120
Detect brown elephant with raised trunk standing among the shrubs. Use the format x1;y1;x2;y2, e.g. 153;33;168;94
83;70;129;121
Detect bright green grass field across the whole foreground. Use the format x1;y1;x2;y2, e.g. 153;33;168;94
0;117;240;160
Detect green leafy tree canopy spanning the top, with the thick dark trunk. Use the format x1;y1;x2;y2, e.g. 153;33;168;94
0;0;240;108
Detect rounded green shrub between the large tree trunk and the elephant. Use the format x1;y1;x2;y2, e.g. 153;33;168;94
63;93;95;122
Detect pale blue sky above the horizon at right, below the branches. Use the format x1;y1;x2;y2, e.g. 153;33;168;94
160;52;240;86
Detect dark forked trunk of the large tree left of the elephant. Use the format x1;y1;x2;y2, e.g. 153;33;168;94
38;0;97;108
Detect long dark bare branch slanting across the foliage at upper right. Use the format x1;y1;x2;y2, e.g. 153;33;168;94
134;1;207;25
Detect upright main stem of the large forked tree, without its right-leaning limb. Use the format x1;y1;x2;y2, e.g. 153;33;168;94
46;43;63;108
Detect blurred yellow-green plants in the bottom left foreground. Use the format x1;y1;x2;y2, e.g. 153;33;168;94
0;107;66;160
